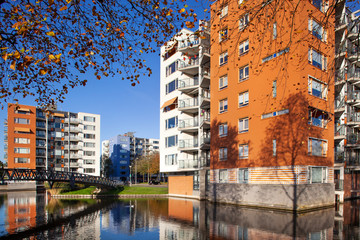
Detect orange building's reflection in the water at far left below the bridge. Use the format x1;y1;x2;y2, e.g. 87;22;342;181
6;191;36;234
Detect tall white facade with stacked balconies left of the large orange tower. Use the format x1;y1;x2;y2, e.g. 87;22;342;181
160;22;210;198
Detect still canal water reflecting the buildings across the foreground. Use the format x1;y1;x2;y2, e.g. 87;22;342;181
0;192;360;240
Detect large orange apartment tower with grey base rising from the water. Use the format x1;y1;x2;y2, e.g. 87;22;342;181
207;0;335;210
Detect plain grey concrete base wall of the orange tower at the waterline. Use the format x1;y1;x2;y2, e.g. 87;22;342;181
207;183;335;211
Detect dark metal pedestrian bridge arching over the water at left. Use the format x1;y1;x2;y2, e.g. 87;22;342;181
0;168;117;188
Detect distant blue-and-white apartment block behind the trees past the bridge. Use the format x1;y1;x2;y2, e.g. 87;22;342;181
102;132;159;182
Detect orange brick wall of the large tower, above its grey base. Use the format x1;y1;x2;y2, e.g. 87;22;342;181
211;1;335;183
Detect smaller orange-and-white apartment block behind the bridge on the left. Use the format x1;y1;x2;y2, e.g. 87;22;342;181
5;104;100;176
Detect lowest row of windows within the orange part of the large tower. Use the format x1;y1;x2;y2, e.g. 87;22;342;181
219;138;328;161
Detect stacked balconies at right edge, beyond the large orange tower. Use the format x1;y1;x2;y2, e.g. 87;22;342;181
335;1;360;202
